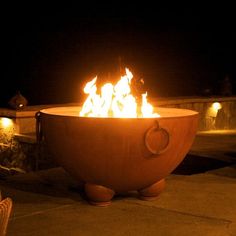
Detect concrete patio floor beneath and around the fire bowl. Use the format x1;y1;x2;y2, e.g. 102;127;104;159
0;132;236;236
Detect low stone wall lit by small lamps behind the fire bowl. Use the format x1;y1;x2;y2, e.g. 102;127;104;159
0;97;236;173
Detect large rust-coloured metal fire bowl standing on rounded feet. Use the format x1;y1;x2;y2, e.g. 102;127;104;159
38;68;198;206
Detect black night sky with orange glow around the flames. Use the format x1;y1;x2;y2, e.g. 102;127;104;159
0;3;236;106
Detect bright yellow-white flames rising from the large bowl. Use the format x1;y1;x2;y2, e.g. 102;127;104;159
80;68;159;118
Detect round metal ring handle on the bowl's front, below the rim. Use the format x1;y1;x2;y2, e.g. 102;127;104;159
144;120;170;155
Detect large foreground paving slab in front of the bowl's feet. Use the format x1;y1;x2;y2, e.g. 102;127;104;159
8;198;230;236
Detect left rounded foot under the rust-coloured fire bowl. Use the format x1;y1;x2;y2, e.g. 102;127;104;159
85;183;115;206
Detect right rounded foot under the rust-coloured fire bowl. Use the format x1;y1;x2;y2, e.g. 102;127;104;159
138;179;165;201
